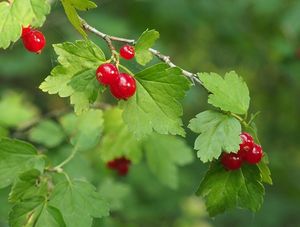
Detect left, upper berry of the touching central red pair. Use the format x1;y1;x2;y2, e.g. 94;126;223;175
96;63;119;85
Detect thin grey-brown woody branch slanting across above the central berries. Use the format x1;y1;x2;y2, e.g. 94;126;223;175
82;20;202;85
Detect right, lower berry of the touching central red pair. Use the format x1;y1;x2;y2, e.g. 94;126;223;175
110;73;136;100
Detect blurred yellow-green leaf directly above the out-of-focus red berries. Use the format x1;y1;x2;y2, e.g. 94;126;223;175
98;108;142;163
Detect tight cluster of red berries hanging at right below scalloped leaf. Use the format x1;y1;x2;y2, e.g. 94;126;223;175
221;132;263;170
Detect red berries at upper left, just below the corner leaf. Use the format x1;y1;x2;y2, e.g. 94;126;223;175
22;26;46;54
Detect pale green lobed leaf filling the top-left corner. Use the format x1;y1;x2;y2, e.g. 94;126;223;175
0;0;50;49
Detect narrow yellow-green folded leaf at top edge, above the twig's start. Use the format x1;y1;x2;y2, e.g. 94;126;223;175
61;0;97;38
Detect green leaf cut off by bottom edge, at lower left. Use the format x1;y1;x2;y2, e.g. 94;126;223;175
9;197;66;227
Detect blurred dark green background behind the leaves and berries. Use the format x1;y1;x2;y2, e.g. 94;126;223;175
0;0;300;227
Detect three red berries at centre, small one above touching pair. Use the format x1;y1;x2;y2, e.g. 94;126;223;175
96;45;136;100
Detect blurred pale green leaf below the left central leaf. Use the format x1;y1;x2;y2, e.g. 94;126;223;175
60;109;103;150
